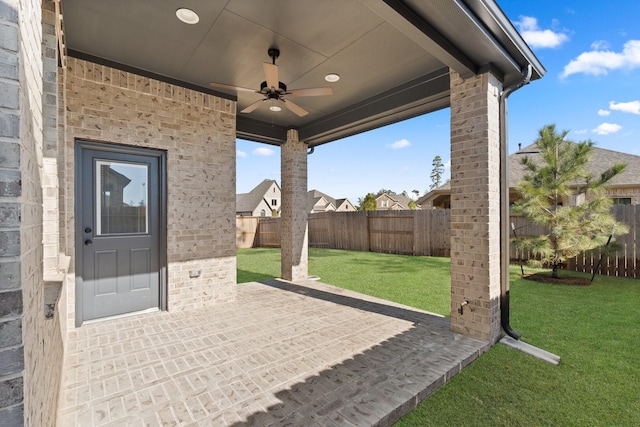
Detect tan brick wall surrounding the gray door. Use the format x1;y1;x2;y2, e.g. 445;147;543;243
63;58;236;325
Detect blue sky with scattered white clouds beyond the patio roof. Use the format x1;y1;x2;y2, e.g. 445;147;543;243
236;0;640;204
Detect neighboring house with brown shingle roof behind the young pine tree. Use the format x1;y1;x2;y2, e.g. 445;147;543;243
417;144;640;209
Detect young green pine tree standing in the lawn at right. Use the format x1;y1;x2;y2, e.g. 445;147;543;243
513;125;628;278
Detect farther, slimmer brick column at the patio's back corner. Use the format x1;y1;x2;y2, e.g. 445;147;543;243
280;129;309;281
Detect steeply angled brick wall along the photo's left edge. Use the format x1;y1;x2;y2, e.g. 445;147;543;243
0;0;62;426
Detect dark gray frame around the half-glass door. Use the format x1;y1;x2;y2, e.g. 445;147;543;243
73;138;167;327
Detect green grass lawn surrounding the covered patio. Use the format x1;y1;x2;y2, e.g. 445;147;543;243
238;249;640;426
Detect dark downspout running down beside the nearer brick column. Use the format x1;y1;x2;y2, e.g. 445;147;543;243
499;64;533;340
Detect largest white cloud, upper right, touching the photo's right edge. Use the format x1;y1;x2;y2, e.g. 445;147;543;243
562;40;640;77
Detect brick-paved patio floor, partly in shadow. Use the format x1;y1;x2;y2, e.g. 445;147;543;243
58;280;487;427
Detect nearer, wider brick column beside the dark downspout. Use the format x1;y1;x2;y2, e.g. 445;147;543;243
450;70;502;343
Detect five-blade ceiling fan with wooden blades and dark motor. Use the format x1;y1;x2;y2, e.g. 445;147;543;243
211;48;333;117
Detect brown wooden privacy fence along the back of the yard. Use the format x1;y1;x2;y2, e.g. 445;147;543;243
236;205;640;278
